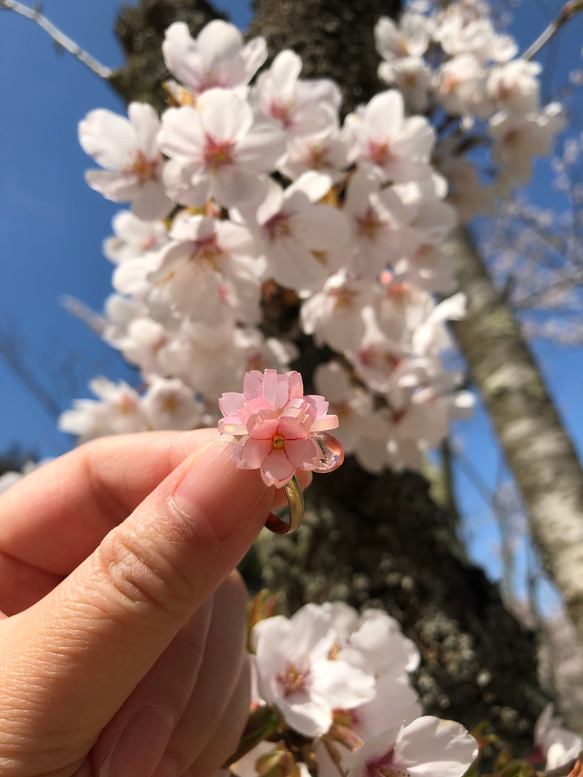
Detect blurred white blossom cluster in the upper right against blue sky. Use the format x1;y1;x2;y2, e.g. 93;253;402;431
375;0;563;221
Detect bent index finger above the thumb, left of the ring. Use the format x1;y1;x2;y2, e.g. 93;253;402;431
0;429;218;575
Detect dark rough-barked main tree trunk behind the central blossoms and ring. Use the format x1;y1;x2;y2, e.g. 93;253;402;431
108;0;545;752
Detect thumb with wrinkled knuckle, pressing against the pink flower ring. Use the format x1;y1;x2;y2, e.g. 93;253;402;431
0;438;273;760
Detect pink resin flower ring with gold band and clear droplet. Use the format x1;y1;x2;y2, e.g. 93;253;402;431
219;370;344;534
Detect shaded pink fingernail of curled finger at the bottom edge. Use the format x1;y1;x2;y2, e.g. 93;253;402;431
99;705;175;777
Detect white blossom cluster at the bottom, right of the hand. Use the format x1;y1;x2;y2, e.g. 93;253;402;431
231;602;478;777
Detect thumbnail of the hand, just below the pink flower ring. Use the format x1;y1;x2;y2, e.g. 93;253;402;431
172;437;267;542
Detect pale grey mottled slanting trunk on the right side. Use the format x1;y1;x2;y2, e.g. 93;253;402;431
446;229;583;642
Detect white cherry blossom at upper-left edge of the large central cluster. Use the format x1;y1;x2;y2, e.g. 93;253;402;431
79;103;172;221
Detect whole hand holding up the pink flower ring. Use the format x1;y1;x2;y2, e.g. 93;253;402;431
0;430;306;777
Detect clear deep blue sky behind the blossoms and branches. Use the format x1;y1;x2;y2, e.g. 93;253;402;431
0;0;583;600
